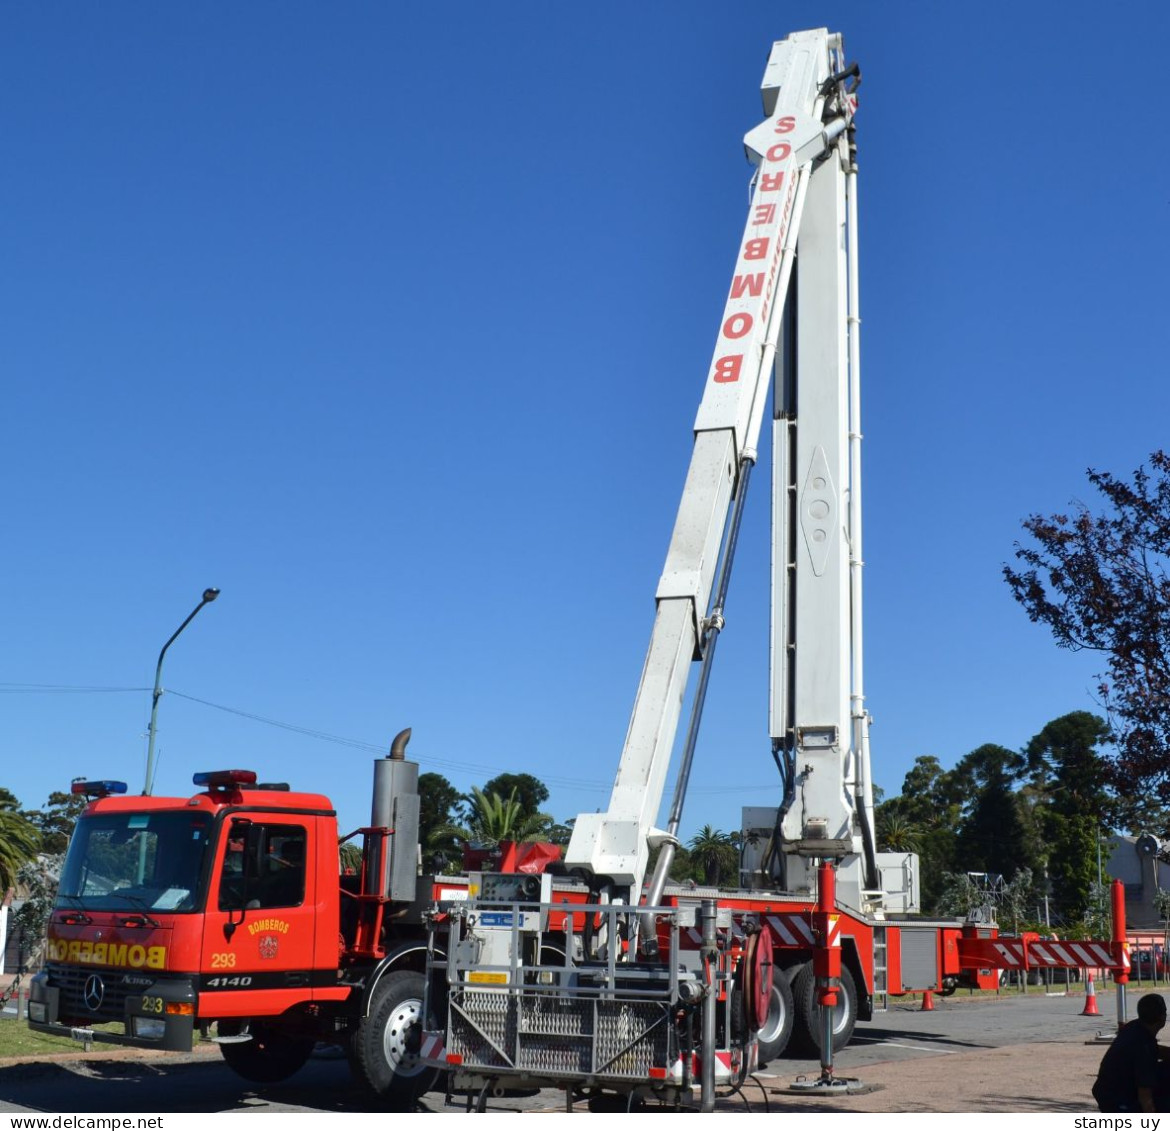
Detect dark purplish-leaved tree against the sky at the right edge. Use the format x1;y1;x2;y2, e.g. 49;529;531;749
1004;451;1170;805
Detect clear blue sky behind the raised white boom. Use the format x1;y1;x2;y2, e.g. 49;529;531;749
0;0;1170;835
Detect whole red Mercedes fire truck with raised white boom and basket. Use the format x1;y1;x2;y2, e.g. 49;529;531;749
29;29;1127;1104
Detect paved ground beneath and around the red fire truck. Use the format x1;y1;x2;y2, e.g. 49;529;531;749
0;989;1132;1112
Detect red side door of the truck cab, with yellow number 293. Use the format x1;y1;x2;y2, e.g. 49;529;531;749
199;813;316;1016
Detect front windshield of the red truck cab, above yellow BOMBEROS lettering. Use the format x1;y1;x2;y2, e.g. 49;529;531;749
57;812;211;911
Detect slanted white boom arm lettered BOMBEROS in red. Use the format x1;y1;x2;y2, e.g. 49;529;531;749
565;29;847;902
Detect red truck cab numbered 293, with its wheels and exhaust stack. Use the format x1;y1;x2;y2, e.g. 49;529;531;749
28;731;444;1104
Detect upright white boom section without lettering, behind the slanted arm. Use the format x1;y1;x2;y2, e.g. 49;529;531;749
770;44;878;887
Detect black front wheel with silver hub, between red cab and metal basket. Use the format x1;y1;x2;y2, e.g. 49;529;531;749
350;970;439;1110
